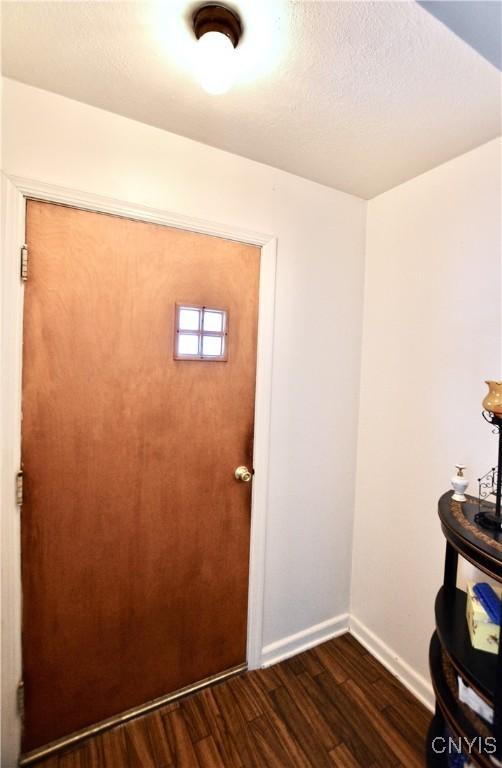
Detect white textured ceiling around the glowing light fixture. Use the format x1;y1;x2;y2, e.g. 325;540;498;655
3;0;501;198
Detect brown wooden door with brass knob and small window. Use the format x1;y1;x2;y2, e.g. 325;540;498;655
21;201;260;751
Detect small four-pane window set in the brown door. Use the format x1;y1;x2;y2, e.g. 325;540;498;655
174;304;228;361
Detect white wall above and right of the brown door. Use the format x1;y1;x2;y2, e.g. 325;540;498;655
3;80;366;760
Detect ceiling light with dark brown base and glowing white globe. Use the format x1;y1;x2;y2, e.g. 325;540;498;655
193;4;242;94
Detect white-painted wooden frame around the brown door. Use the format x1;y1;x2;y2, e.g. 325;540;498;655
0;173;277;768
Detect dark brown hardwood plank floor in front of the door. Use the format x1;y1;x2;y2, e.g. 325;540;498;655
33;634;431;768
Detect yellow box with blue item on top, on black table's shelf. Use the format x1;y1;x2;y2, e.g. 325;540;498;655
466;581;502;653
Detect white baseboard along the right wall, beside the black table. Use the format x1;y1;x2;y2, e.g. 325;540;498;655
350;616;434;712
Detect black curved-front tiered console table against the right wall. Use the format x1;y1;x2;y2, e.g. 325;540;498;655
427;492;502;768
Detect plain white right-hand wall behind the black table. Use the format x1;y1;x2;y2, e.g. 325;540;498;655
351;140;501;708
